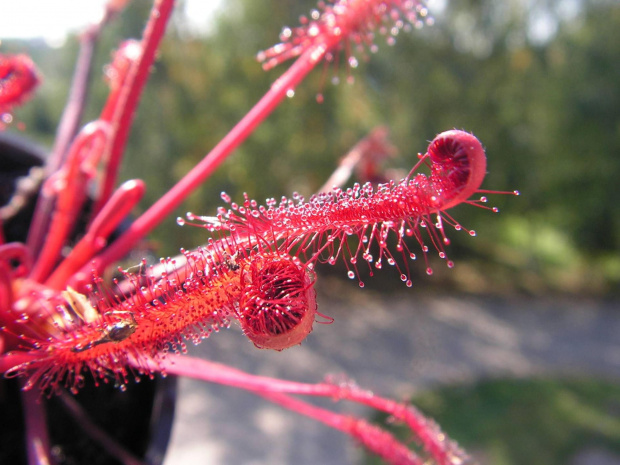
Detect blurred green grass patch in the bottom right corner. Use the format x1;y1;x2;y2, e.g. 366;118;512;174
365;378;620;465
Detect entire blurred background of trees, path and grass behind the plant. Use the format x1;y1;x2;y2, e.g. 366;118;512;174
0;0;620;465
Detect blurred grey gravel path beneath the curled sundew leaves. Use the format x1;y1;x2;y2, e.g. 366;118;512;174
165;282;620;465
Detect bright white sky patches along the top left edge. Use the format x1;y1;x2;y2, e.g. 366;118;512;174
0;0;221;45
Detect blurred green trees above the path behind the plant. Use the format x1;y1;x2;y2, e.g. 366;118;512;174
2;0;620;293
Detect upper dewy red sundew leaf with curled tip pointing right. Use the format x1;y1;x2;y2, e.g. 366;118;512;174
182;130;486;286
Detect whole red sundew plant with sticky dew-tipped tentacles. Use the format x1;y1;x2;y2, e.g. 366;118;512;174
0;0;520;465
